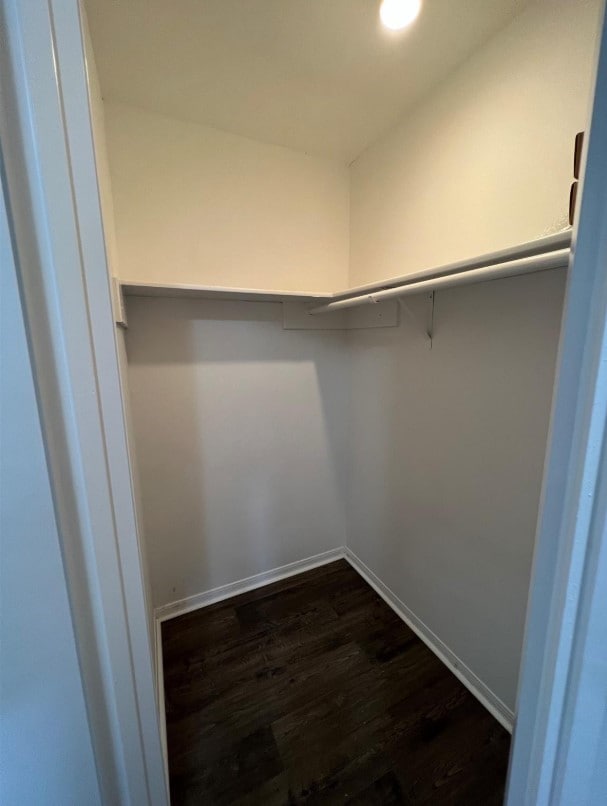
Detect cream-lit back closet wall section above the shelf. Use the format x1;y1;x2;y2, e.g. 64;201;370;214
105;104;349;291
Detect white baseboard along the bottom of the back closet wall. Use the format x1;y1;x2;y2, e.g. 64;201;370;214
154;546;345;622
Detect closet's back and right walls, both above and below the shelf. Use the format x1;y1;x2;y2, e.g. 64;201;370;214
98;0;599;720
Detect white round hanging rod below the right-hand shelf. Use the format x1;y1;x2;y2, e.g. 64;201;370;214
308;249;570;315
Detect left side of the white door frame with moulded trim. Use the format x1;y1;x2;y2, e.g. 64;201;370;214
0;0;169;806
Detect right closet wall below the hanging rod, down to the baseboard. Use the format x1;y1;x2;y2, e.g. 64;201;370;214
348;270;565;710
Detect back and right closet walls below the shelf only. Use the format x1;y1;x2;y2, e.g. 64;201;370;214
127;270;565;709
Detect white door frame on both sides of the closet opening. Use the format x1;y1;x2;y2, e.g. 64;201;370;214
0;0;607;806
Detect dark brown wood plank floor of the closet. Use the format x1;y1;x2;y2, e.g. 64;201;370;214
162;561;509;806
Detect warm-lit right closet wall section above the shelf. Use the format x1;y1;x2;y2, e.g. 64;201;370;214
350;0;602;286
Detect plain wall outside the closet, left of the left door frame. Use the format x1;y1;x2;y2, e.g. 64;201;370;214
0;197;101;806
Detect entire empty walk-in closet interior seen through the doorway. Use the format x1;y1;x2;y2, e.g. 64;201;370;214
82;0;603;806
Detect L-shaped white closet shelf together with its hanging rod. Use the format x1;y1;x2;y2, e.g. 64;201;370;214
120;234;571;313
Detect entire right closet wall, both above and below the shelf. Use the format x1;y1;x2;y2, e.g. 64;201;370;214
348;0;600;710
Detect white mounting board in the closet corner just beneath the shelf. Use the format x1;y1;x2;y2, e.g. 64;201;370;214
282;300;399;330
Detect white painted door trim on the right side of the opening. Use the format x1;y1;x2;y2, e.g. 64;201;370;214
506;3;607;806
